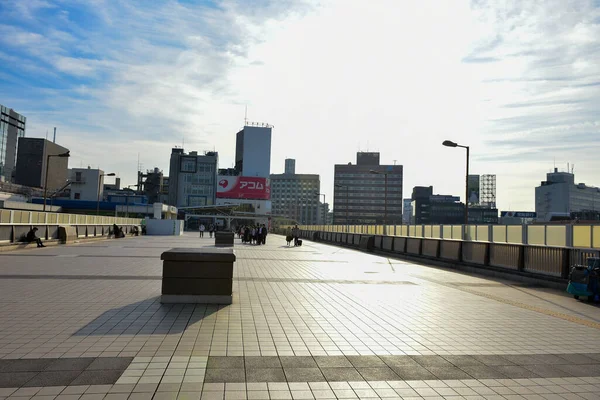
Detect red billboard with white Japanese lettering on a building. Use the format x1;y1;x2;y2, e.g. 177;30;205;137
217;175;271;200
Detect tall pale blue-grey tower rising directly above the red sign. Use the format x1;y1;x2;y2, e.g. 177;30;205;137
235;124;273;178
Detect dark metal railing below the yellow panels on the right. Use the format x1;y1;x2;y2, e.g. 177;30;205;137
288;229;600;279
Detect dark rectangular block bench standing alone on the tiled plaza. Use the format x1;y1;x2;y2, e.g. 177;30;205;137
160;247;235;304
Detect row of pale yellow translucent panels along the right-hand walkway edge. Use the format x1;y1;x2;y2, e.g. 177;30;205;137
300;225;600;249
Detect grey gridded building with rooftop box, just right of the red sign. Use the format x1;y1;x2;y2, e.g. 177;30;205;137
271;160;321;225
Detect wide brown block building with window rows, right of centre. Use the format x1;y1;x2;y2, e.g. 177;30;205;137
333;152;403;225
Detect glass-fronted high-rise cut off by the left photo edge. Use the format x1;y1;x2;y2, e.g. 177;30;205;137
0;105;27;182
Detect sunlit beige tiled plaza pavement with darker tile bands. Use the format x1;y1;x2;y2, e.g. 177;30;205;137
0;234;600;400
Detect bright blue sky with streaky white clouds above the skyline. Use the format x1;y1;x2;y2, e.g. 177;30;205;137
0;0;600;211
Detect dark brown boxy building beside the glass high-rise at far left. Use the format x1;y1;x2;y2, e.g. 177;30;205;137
14;137;69;191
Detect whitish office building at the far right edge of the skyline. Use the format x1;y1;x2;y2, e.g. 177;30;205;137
535;168;600;221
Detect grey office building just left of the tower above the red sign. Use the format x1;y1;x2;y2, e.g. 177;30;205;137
169;148;219;208
